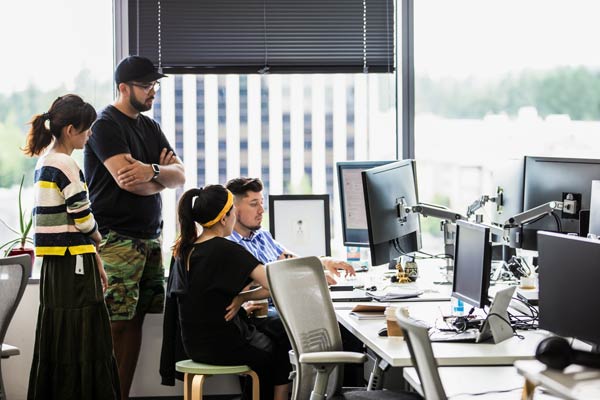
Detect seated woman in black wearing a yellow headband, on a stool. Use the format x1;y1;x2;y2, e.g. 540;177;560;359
174;185;291;400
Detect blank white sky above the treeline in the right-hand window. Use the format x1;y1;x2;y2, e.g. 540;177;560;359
414;0;600;77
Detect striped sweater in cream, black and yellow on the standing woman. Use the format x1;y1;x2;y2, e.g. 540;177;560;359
33;153;97;256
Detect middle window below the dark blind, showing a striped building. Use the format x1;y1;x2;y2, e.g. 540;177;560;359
153;74;396;254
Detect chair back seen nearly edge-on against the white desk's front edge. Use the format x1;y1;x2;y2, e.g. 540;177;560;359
396;310;446;400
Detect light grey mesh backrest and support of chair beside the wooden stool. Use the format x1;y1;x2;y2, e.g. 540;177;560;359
267;257;342;399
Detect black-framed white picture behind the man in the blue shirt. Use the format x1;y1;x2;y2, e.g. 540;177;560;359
269;194;331;256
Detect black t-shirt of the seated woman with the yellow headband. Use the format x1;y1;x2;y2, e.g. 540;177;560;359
177;237;260;359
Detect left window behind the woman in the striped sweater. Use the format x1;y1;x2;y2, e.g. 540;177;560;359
0;0;114;274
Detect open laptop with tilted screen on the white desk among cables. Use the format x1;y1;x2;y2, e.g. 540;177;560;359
429;286;515;343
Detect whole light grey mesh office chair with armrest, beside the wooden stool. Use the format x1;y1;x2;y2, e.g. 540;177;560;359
267;257;421;400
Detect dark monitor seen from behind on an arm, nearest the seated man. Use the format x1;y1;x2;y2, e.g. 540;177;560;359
361;160;421;265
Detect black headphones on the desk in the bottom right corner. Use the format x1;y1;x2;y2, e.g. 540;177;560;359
535;336;600;370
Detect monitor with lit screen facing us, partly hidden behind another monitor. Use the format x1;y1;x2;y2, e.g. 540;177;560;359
337;161;392;247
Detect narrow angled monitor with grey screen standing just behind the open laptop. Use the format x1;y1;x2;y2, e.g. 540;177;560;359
452;220;492;308
